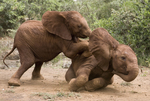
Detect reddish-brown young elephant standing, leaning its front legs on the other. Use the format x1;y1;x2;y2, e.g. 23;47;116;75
3;11;91;86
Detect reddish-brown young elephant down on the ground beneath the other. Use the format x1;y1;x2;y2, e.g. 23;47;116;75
65;28;139;91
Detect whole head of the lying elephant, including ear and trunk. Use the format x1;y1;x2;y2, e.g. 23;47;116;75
89;28;139;82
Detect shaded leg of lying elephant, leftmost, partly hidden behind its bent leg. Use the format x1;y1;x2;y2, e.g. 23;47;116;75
65;65;76;82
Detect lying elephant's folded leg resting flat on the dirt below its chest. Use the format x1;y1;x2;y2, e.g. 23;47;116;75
85;78;108;91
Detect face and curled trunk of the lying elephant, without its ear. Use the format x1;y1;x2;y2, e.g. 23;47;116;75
112;44;139;82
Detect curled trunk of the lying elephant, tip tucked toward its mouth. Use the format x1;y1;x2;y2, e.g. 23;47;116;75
114;65;139;82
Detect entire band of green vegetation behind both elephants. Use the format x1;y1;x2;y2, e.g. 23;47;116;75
0;0;150;67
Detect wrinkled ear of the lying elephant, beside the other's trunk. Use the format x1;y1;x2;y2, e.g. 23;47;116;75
89;28;119;71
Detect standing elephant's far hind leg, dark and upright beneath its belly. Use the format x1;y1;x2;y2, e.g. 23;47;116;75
31;62;44;80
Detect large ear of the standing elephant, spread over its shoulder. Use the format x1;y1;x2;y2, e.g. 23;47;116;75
42;11;72;40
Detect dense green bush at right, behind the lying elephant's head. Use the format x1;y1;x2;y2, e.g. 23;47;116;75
94;0;150;66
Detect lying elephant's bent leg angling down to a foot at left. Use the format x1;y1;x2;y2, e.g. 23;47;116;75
69;68;91;91
